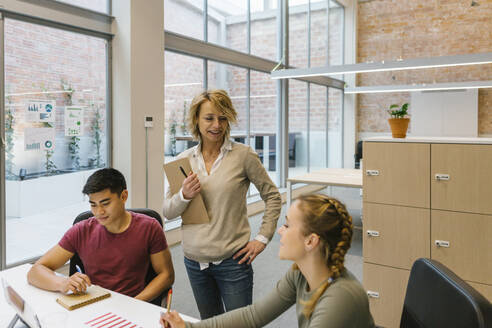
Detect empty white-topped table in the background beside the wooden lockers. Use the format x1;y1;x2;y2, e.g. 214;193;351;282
287;168;362;209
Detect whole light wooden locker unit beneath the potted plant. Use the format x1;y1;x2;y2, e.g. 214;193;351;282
363;138;492;327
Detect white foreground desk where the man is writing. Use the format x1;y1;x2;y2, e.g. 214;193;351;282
0;264;198;328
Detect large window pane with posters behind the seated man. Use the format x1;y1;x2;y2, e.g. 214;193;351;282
2;18;108;265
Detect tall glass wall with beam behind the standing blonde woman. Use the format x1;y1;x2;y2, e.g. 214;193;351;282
164;0;344;195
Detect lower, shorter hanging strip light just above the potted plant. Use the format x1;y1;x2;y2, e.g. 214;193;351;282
343;81;492;94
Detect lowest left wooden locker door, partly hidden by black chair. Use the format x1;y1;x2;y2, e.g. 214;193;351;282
363;263;410;327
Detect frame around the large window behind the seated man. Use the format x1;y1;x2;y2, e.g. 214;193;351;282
0;0;114;270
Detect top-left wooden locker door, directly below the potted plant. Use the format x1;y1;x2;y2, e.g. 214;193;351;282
363;142;430;208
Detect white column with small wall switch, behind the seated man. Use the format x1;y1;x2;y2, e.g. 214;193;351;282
112;0;164;212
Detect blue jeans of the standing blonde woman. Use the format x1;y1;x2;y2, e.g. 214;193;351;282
184;257;253;320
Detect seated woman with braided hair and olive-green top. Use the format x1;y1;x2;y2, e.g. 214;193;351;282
160;195;374;328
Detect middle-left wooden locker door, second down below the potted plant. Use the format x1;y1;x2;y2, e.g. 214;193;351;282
362;203;430;270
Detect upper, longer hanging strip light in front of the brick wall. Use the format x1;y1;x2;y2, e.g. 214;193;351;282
270;52;492;79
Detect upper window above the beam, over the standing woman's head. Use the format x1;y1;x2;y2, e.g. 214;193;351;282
164;0;278;60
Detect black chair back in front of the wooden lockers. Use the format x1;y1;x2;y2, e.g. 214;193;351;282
400;258;492;328
